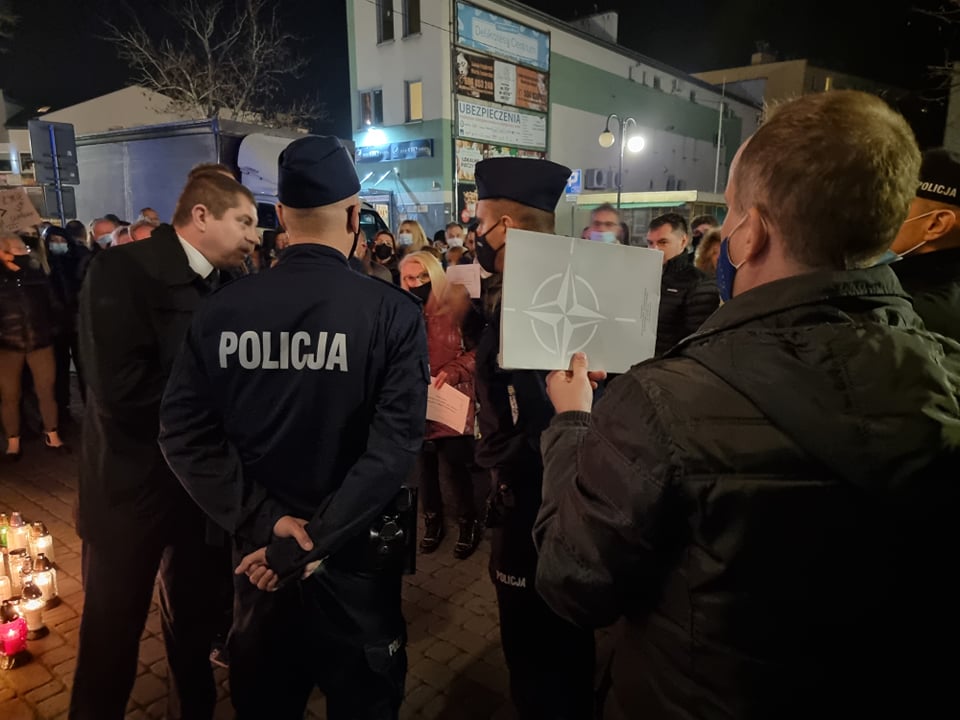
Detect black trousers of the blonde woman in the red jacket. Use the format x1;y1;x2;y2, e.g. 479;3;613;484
417;435;477;520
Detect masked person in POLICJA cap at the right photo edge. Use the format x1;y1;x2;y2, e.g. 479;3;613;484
891;148;960;341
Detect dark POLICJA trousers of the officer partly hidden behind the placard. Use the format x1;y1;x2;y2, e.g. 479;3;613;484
490;465;596;720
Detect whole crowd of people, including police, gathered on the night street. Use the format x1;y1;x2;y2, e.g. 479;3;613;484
0;91;960;720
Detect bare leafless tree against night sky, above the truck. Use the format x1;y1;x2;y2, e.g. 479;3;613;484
106;0;318;125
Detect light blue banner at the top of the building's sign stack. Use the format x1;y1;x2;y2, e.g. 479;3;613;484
457;2;550;70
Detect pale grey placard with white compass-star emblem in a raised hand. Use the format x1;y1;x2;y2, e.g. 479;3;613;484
500;229;663;373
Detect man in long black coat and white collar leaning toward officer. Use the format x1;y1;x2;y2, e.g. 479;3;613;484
70;173;257;720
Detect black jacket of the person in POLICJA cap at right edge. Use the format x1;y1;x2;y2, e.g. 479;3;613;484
890;248;960;341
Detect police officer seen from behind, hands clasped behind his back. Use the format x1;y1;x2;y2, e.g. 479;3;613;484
160;136;430;720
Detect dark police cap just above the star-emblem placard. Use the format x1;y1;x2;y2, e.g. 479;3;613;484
474;157;570;213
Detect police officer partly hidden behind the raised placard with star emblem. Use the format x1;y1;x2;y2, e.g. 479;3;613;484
476;158;595;720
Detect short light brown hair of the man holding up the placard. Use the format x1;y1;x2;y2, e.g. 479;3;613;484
733;90;920;270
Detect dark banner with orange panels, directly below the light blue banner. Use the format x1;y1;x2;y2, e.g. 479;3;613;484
455;49;549;112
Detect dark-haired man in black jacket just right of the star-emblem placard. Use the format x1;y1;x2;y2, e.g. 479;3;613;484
647;213;720;357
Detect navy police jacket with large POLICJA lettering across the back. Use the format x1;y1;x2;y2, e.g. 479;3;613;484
160;245;430;577
